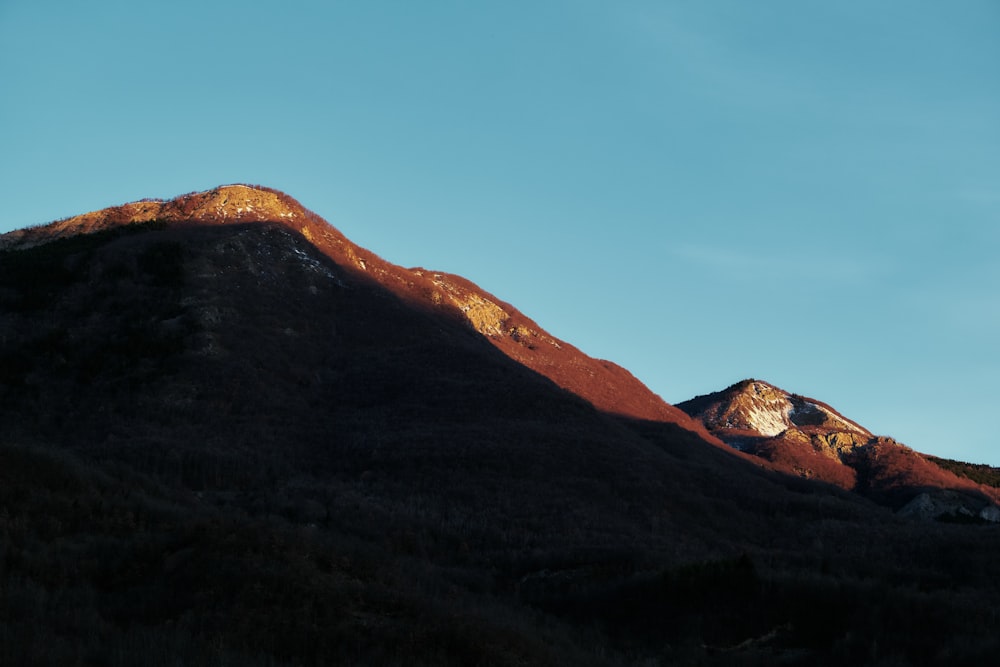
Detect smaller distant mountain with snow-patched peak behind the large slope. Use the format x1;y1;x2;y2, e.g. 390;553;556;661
677;379;1000;521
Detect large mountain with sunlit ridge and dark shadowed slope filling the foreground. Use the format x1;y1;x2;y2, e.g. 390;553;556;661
0;187;1000;665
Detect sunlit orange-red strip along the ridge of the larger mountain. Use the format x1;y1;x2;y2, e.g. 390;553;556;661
0;185;720;444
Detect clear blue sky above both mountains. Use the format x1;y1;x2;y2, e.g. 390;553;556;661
0;0;1000;465
